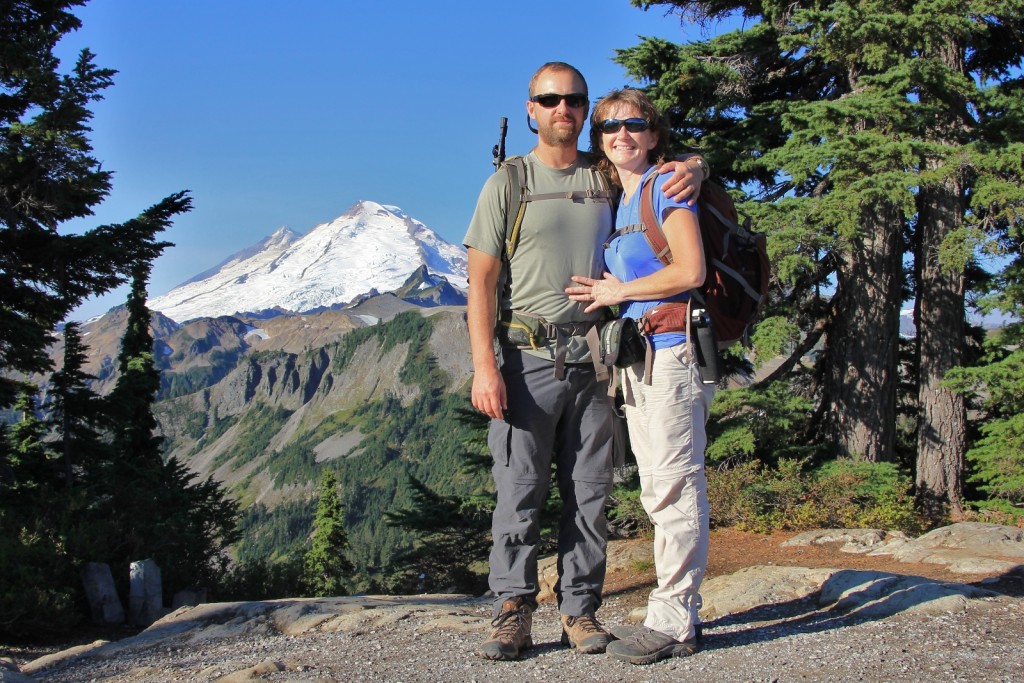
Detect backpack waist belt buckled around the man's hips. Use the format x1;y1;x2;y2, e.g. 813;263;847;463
497;310;608;381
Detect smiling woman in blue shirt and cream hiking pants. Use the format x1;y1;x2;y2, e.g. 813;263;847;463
566;89;715;664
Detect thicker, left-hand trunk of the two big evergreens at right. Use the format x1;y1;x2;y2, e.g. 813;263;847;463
821;200;902;461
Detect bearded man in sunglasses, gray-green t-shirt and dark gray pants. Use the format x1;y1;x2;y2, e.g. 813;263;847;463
464;62;704;659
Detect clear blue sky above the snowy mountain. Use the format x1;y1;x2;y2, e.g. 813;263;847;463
58;0;733;318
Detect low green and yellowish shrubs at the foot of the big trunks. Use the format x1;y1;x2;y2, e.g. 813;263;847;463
708;459;925;532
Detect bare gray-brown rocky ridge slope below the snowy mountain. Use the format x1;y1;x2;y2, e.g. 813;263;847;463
157;302;471;505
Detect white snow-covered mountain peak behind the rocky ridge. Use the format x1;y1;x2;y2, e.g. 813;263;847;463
147;201;468;323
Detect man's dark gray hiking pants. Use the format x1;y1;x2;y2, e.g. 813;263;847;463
487;348;612;616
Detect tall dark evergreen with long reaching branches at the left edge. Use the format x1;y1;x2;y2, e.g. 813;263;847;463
0;0;188;409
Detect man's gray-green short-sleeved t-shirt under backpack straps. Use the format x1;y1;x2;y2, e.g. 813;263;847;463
463;153;612;362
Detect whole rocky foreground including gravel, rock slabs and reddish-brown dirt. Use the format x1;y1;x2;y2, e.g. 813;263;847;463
0;529;1024;683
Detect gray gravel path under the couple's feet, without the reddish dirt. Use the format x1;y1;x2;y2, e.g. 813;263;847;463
22;597;1024;683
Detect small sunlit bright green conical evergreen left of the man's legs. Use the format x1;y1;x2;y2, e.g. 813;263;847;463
304;470;352;597
